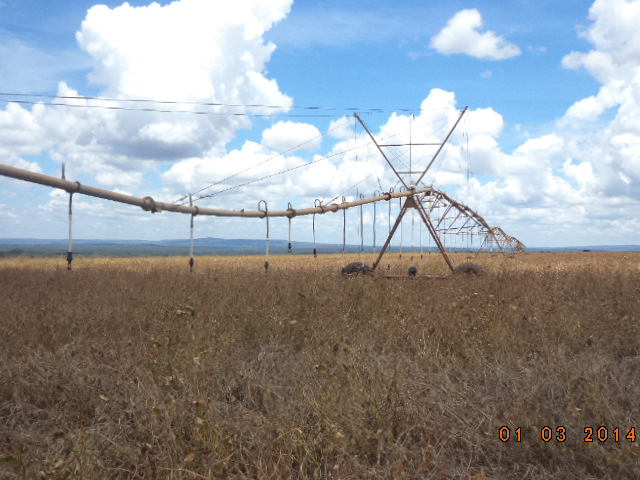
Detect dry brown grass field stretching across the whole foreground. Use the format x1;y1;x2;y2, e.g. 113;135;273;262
0;253;640;480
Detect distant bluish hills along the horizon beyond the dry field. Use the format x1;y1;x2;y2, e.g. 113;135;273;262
0;237;640;257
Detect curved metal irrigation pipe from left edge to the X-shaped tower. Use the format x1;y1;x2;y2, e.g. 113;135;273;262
0;164;439;218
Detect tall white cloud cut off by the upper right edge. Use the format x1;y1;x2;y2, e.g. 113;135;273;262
560;0;640;200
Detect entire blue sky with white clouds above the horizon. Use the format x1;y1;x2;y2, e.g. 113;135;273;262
0;0;640;246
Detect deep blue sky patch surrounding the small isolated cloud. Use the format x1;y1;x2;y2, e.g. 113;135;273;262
268;0;597;125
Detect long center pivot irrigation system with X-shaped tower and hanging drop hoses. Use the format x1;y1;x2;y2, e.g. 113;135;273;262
0;107;525;271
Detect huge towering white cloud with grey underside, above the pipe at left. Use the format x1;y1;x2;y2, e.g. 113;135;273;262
0;0;292;188
